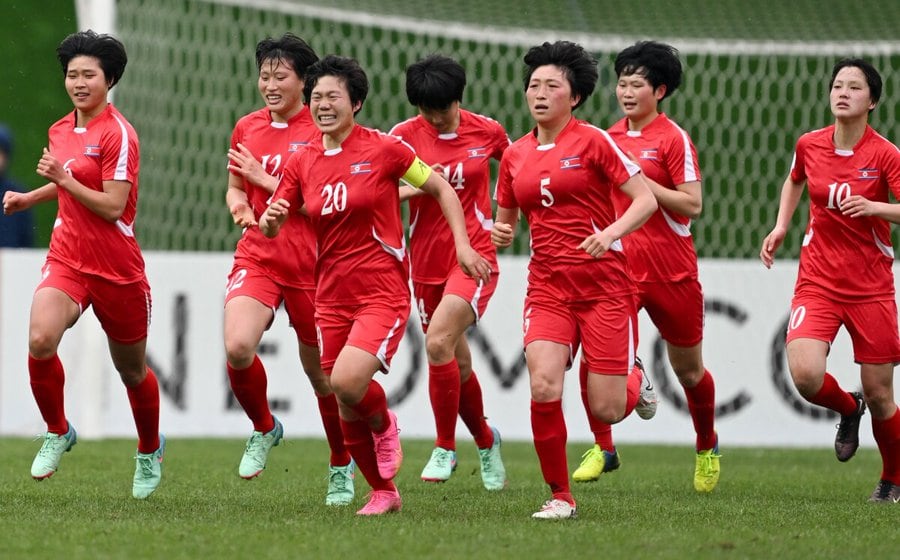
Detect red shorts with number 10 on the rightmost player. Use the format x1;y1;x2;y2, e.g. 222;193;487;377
787;293;900;364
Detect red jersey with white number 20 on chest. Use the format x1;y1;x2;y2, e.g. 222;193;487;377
273;125;416;305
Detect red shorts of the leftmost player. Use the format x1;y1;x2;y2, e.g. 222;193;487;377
35;260;151;344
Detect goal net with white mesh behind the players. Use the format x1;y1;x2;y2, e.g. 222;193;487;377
96;0;900;258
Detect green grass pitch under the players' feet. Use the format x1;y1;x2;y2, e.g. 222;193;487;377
0;438;900;560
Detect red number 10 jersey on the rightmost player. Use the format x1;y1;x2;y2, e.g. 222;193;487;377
791;125;900;301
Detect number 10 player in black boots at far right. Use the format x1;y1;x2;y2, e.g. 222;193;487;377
759;58;900;503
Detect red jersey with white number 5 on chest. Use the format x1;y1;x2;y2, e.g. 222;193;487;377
497;118;640;301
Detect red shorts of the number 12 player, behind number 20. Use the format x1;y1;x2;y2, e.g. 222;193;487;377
225;263;317;346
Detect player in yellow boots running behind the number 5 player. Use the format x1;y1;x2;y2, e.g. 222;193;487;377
572;41;720;492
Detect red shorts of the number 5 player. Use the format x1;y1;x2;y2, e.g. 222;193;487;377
523;288;638;375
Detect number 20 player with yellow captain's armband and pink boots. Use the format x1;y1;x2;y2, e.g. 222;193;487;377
260;56;491;515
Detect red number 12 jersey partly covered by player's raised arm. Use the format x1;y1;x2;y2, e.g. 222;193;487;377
231;106;319;289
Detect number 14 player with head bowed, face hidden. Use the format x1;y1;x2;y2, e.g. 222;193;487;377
391;55;509;490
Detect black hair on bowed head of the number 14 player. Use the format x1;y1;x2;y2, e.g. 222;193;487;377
406;54;466;111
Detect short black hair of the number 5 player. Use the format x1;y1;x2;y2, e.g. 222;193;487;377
523;41;599;109
